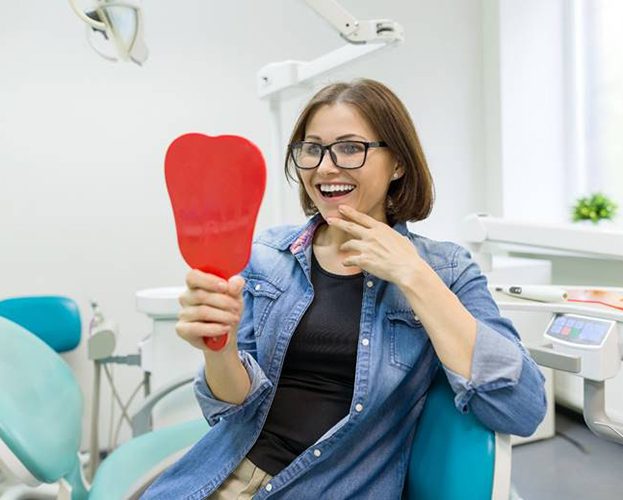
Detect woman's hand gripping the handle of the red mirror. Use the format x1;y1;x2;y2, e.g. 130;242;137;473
175;269;245;355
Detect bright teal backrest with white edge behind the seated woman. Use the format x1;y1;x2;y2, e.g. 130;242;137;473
403;369;511;500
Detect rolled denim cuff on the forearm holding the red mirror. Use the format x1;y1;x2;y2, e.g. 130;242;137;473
194;351;272;426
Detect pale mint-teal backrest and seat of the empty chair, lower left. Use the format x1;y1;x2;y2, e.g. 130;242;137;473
0;317;209;500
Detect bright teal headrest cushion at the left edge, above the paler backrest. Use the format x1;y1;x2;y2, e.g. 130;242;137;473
0;295;82;352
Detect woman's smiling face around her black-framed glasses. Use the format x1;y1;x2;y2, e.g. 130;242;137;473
298;103;402;222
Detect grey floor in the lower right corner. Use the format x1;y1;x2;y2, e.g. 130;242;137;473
512;408;623;500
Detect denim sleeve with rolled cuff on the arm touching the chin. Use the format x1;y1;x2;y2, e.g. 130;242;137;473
444;247;547;436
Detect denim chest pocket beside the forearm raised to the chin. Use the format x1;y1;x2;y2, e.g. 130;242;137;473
387;310;428;370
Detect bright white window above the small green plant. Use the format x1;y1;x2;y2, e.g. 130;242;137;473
570;0;623;220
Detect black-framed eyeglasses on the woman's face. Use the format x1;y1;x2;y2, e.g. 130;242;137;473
288;141;387;170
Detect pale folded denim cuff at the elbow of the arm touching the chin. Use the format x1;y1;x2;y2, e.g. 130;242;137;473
443;321;523;413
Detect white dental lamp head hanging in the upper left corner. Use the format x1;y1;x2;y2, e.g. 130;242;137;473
69;0;148;65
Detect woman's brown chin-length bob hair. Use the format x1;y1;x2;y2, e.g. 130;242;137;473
285;79;434;224
